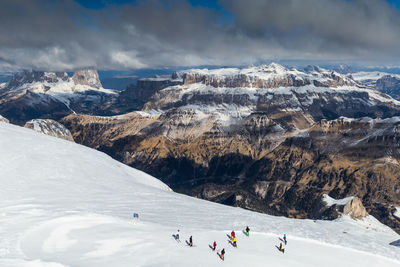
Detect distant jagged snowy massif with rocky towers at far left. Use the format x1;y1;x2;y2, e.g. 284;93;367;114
0;70;118;124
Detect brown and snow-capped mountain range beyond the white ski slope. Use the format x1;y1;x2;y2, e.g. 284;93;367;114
0;64;400;236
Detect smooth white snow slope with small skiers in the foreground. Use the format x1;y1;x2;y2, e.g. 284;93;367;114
0;123;400;267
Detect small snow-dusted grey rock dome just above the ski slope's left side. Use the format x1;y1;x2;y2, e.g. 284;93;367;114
24;119;74;141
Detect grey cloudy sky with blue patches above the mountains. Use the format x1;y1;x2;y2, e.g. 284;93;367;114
0;0;400;71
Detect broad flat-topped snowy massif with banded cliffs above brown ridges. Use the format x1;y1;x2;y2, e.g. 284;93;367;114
144;68;400;125
